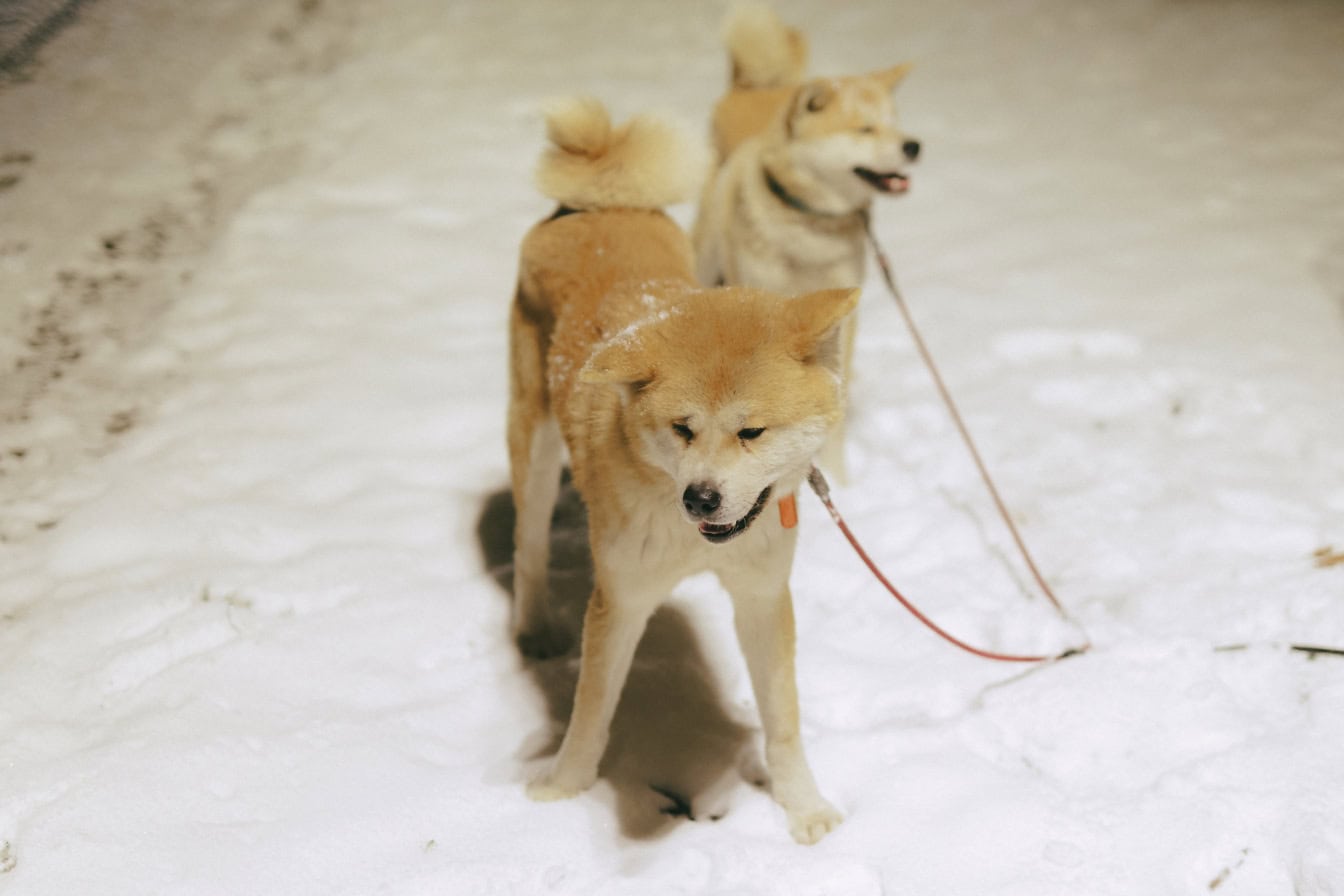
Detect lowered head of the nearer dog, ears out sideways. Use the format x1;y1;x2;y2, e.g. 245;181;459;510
581;287;859;543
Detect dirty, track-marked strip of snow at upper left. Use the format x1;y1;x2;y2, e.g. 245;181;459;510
0;0;352;544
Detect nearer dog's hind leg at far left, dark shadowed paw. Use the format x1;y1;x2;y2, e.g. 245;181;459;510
508;300;571;657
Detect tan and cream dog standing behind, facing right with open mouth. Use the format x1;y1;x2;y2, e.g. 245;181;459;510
692;7;921;481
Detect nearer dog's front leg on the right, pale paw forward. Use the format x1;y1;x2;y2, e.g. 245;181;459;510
720;575;841;844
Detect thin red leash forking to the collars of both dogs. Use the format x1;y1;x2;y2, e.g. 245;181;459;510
808;214;1091;662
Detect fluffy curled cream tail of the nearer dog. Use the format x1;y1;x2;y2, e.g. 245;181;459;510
536;97;708;208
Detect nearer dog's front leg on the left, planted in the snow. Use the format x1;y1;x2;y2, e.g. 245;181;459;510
527;580;660;801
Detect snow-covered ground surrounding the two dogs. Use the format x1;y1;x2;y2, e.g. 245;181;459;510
0;0;1344;896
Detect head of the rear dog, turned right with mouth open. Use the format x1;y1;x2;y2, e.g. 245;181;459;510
786;64;919;206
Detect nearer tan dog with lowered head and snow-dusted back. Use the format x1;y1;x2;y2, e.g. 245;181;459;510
508;99;859;842
